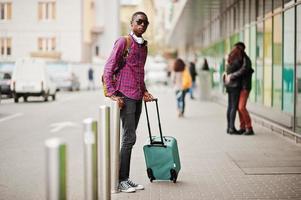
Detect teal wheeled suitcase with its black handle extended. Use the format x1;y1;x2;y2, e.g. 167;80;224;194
143;99;181;183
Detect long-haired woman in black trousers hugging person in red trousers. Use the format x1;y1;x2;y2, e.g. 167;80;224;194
224;46;243;135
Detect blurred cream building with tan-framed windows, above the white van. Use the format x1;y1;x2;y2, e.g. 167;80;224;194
0;0;119;63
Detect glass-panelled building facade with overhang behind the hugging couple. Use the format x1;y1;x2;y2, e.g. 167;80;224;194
168;0;301;134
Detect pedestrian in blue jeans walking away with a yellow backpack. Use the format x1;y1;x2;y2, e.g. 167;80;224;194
172;58;192;117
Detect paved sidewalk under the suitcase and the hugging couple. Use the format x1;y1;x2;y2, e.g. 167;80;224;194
112;88;301;200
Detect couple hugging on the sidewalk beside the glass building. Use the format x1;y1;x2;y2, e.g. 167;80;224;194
223;42;254;135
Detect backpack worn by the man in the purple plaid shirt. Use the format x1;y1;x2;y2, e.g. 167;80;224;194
101;35;131;97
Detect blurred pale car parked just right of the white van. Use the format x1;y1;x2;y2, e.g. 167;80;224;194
47;63;80;91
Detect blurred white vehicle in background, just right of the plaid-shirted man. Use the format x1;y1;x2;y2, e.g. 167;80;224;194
145;57;168;85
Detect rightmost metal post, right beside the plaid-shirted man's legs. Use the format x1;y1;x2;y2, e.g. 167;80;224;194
111;101;120;193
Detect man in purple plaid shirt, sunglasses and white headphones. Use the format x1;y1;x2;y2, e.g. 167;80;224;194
103;12;154;192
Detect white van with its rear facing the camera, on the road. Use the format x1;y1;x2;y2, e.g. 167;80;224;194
11;58;57;103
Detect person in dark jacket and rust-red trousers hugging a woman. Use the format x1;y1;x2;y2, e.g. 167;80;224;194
228;42;254;135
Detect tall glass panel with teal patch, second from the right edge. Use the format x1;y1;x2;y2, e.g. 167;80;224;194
283;8;295;114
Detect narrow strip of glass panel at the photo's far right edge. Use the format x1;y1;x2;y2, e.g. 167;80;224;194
296;5;301;134
